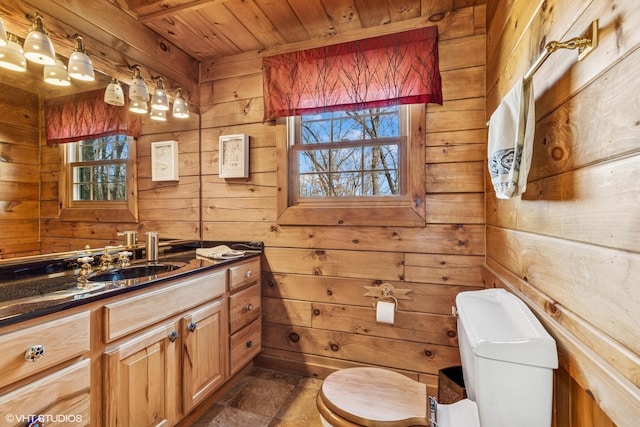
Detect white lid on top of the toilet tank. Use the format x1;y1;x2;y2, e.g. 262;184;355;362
456;288;558;369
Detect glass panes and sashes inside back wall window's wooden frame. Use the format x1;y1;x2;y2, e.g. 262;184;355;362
290;106;406;203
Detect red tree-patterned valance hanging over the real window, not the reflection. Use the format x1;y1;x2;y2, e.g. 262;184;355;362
262;26;442;120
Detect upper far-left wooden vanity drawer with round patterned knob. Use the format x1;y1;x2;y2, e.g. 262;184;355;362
0;311;90;387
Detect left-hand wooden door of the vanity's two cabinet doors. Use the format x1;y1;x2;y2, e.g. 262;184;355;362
104;322;180;427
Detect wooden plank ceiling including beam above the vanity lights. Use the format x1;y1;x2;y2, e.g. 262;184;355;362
0;0;487;106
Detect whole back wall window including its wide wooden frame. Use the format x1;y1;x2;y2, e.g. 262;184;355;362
278;104;425;226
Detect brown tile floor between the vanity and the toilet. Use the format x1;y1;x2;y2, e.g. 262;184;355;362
192;368;322;427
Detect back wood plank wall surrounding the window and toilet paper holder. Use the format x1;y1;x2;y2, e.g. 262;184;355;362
200;6;486;394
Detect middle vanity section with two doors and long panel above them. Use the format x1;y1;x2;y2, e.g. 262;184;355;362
103;270;228;427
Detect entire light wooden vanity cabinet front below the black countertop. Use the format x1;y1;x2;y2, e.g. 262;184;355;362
0;257;261;427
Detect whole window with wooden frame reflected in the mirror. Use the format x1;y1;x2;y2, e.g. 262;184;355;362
60;135;137;222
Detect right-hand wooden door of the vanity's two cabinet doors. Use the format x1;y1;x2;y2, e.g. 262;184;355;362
181;298;229;414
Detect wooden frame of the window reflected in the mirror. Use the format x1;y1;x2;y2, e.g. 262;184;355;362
58;137;138;222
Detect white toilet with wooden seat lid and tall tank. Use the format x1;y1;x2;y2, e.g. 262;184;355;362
317;289;558;427
